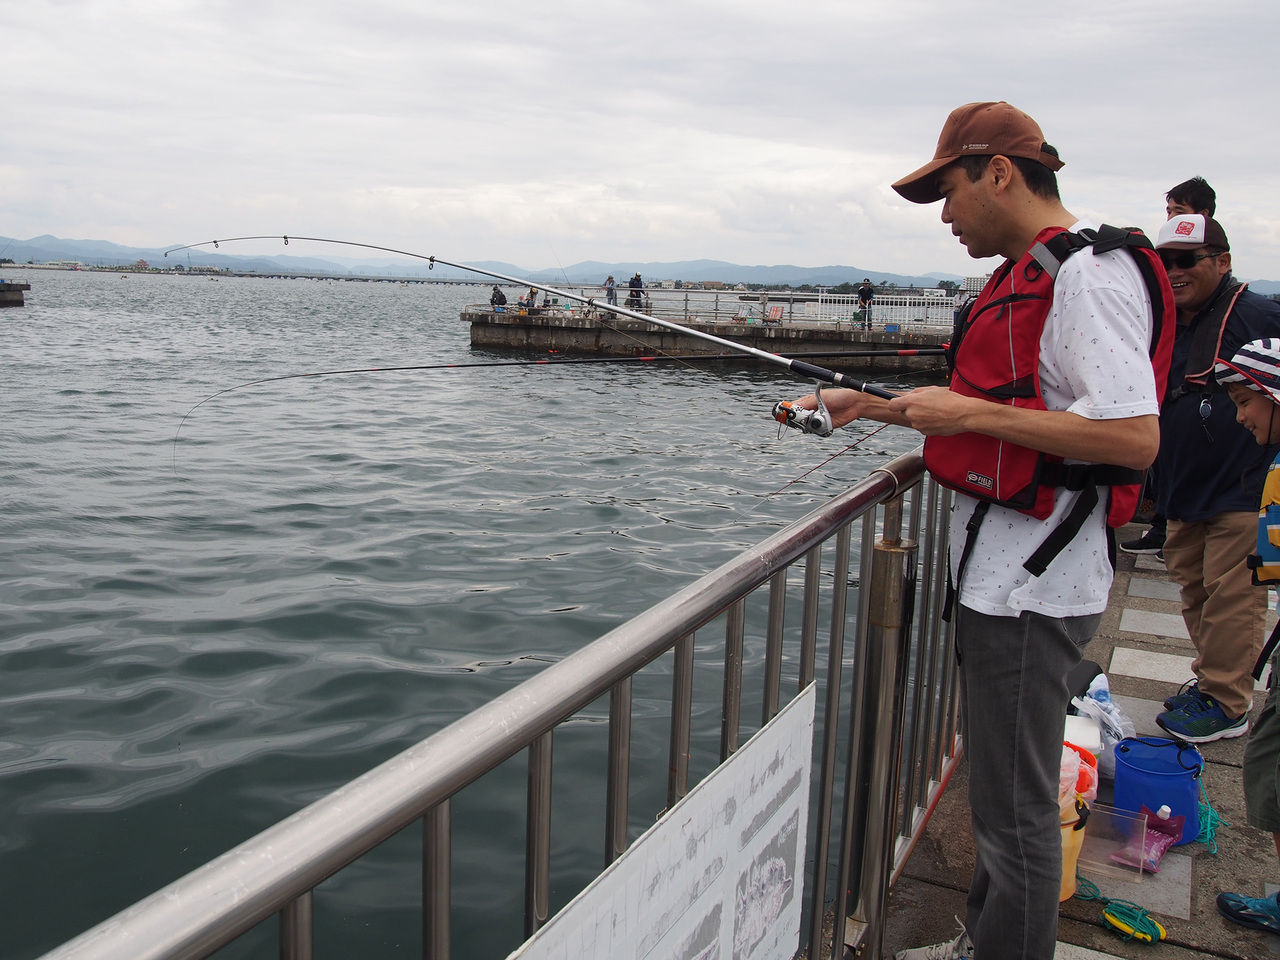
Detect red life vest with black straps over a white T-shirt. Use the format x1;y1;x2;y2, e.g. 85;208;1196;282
924;225;1176;575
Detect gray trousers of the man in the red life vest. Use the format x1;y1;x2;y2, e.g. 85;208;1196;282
956;607;1102;960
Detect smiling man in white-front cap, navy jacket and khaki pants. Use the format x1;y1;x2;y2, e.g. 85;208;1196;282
1156;214;1280;744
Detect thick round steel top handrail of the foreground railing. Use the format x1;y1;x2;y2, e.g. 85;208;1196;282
45;451;924;960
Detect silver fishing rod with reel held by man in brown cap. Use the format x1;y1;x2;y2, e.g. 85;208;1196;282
164;236;896;436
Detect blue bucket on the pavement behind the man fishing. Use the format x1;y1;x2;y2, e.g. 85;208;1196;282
1115;737;1204;844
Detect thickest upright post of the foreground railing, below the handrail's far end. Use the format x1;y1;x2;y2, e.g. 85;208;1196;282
837;497;916;957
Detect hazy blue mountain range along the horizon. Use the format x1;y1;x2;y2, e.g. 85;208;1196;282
0;234;1280;296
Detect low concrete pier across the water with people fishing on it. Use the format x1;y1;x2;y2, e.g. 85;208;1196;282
461;305;951;375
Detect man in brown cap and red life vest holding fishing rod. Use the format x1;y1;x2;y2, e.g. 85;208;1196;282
801;102;1172;960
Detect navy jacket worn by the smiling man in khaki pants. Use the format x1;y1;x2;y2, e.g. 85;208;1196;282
1156;274;1280;522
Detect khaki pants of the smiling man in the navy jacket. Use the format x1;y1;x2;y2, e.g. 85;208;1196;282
1165;512;1267;718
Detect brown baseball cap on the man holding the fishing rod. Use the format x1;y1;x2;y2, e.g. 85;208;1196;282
893;100;1062;204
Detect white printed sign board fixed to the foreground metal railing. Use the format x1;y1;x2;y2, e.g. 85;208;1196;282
508;684;815;960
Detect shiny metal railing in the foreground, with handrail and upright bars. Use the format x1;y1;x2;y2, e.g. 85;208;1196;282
46;452;959;960
